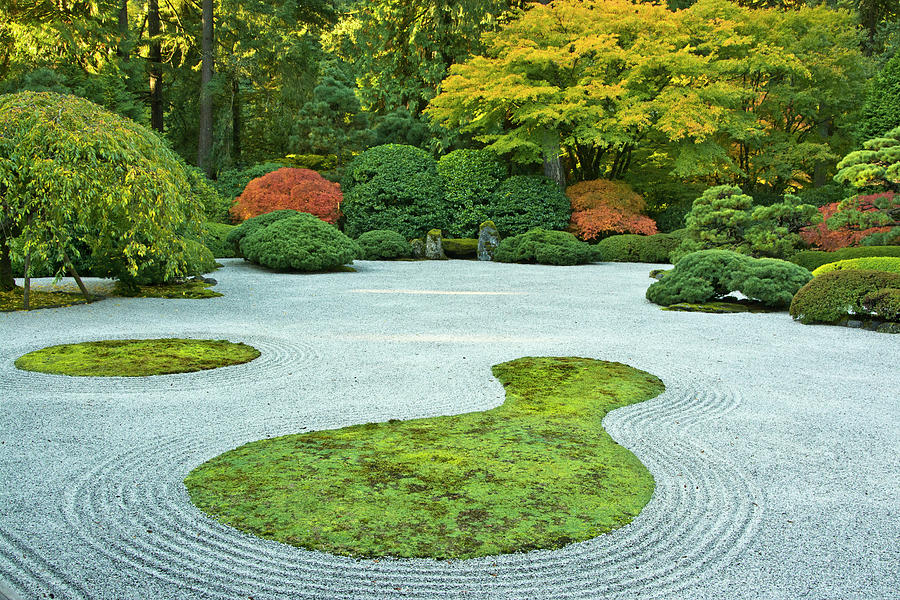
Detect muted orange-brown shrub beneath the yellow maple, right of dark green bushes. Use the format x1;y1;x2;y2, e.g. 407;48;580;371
566;179;656;240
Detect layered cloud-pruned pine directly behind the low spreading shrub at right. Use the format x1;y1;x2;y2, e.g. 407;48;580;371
672;185;818;262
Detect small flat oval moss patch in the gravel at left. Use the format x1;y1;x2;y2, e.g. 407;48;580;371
16;338;259;377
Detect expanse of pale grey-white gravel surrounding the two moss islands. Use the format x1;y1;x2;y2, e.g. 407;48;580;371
0;260;900;600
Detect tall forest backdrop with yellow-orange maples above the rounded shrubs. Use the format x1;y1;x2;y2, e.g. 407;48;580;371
0;0;900;213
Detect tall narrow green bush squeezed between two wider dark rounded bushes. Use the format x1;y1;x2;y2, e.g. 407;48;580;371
438;150;507;238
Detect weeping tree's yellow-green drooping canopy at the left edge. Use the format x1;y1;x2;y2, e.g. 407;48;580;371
0;92;203;288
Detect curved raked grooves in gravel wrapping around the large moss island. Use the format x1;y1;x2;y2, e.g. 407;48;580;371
40;376;762;599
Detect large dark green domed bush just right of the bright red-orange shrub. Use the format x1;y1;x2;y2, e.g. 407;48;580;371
341;144;453;239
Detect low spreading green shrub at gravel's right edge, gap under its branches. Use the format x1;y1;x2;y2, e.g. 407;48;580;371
647;250;812;307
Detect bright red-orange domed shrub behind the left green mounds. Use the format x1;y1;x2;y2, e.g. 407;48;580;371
231;167;343;223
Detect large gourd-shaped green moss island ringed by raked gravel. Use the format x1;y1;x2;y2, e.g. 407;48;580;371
185;358;664;559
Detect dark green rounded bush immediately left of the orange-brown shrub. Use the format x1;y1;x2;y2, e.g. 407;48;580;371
485;175;572;237
